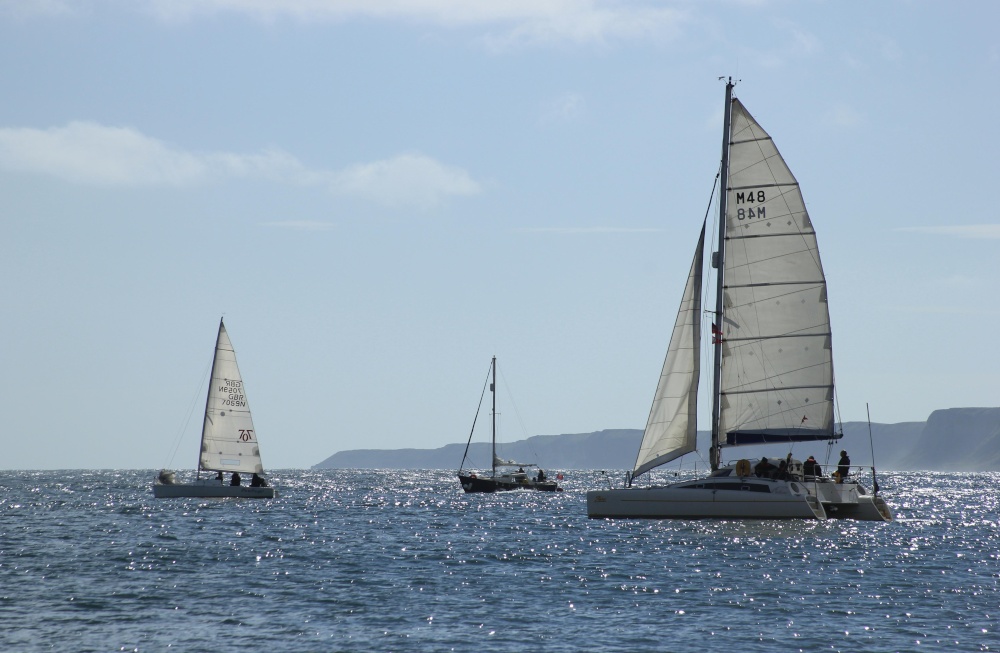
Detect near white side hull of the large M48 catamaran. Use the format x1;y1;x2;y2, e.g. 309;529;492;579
587;487;826;519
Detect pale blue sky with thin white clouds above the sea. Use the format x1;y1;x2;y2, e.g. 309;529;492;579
0;0;1000;469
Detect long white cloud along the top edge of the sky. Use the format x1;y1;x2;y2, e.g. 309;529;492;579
146;0;687;48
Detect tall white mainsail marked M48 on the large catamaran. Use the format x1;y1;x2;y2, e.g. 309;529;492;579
719;99;834;444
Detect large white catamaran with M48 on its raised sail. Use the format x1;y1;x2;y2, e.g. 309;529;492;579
587;79;893;521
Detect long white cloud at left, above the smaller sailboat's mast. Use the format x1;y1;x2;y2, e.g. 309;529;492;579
0;122;481;207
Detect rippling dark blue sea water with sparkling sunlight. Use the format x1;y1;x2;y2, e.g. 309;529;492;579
0;470;1000;653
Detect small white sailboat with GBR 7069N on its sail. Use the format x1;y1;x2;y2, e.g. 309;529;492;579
153;320;276;499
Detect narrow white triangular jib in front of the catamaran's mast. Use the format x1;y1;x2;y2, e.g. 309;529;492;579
632;225;705;477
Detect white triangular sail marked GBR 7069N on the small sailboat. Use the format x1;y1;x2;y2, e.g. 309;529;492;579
199;321;264;474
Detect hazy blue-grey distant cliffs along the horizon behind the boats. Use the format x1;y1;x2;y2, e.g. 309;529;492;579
313;408;1000;471
